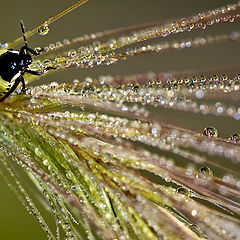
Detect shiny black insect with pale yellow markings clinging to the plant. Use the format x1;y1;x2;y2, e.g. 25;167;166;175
0;21;54;102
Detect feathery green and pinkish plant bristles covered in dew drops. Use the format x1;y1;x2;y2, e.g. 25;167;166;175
0;1;240;240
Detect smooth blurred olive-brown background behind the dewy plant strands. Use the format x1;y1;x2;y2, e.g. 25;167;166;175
0;0;240;240
